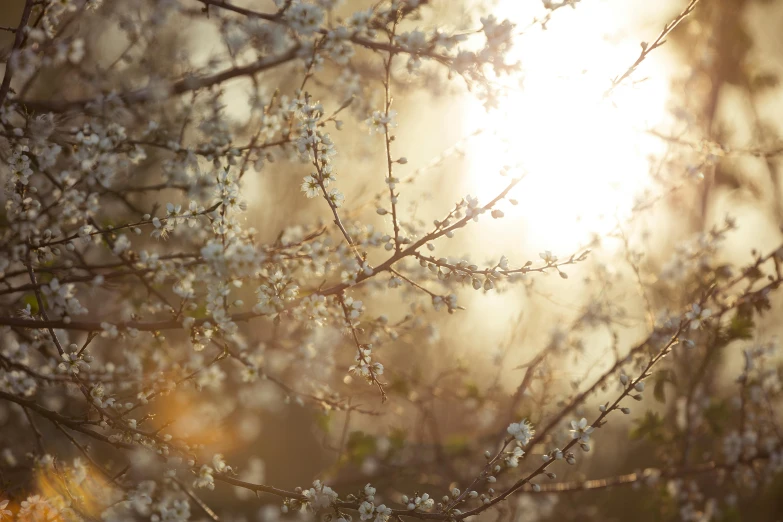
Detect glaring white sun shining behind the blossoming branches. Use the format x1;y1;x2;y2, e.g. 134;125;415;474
465;0;669;249
